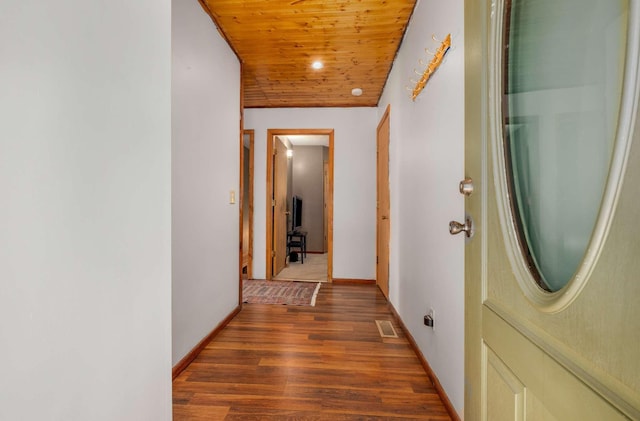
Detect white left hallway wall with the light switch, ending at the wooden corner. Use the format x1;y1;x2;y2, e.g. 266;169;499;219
171;0;240;365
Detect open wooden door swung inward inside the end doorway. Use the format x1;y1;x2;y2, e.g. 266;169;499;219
273;136;287;276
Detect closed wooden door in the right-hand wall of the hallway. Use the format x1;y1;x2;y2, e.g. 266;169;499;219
376;107;391;298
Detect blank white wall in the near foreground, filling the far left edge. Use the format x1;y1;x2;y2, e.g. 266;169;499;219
0;0;171;420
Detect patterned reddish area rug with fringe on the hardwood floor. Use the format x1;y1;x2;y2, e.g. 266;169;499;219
242;279;321;307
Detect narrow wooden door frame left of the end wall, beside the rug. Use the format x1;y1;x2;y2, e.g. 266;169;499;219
239;129;255;279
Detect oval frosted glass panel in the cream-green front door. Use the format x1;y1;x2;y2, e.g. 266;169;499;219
502;0;629;292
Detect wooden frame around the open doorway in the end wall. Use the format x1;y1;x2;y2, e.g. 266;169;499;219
265;129;334;282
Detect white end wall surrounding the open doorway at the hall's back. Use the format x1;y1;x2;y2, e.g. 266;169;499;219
244;108;378;279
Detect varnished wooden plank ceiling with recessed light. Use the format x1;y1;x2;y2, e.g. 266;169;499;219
200;0;415;108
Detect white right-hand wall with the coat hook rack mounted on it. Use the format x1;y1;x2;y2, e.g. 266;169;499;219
378;0;464;415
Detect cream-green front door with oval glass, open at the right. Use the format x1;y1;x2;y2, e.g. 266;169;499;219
459;0;640;421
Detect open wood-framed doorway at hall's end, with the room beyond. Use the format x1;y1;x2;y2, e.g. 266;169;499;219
266;129;333;282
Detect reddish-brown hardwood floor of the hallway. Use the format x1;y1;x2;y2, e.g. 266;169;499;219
173;284;450;420
